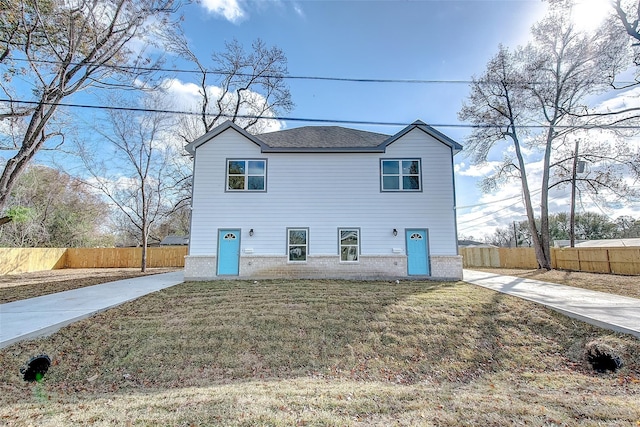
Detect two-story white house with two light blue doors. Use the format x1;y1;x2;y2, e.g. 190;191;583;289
184;121;462;280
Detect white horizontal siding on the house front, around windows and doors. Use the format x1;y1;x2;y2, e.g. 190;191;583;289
185;129;462;278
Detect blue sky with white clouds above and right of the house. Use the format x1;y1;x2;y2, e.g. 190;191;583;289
169;0;640;238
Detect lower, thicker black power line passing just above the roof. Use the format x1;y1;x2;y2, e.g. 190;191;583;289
0;98;639;129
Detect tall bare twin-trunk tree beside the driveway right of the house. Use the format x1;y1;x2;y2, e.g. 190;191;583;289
459;4;632;269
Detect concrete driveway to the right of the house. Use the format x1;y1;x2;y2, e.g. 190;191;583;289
463;270;640;337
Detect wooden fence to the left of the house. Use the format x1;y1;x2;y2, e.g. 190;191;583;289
0;246;187;275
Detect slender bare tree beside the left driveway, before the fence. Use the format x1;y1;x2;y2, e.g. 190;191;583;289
81;94;181;271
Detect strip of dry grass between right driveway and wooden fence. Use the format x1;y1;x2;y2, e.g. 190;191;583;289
471;267;640;298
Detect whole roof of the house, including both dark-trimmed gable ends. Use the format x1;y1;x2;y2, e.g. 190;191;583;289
185;120;462;154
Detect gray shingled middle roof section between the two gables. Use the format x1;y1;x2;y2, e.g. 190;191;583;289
256;126;390;149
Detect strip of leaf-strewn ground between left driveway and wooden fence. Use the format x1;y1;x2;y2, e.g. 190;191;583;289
0;268;179;304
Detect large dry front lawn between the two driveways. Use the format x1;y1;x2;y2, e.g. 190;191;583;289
0;281;640;426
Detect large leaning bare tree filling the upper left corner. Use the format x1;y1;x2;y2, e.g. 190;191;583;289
0;0;181;211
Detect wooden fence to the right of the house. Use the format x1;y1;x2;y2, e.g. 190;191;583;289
460;247;640;275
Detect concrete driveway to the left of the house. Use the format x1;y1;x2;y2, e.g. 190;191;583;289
0;271;184;348
